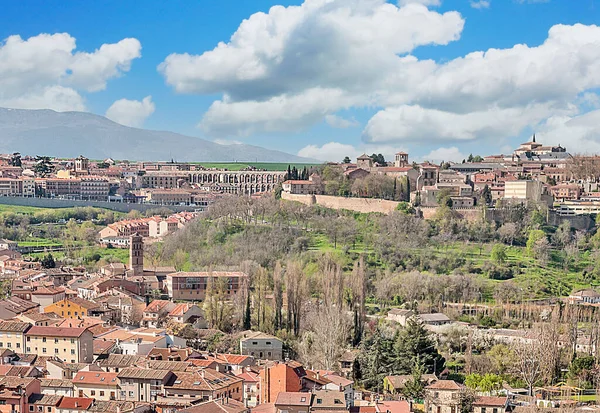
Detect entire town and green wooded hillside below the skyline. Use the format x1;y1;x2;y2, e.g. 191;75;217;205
0;136;600;413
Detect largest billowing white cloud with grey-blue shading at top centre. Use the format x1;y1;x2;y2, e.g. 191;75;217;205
159;0;464;135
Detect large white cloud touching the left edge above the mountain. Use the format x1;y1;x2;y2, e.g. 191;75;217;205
0;33;141;111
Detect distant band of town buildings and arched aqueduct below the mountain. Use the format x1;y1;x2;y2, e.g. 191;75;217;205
0;154;285;204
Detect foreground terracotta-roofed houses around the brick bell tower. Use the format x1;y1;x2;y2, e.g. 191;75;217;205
0;233;596;413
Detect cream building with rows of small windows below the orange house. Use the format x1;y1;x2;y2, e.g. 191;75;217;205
25;326;94;363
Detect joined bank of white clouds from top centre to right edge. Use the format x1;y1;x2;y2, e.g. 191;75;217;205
159;0;600;150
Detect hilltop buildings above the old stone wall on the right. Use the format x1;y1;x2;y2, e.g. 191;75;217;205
283;135;600;216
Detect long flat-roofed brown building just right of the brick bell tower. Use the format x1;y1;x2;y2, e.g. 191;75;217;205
165;271;248;301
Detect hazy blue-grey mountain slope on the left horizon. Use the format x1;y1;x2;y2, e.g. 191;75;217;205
0;108;317;163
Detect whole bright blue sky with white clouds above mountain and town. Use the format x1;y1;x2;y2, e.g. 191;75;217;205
0;0;600;161
